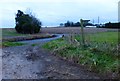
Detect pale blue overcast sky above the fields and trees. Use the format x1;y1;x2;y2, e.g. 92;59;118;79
0;0;119;27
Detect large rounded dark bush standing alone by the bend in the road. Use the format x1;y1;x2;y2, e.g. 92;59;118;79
15;10;41;34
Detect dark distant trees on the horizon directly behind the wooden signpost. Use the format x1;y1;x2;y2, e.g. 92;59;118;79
60;21;94;27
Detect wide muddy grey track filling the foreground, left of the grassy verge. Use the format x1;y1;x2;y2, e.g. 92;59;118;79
2;44;100;79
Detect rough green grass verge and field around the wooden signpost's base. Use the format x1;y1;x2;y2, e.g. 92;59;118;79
43;32;120;73
